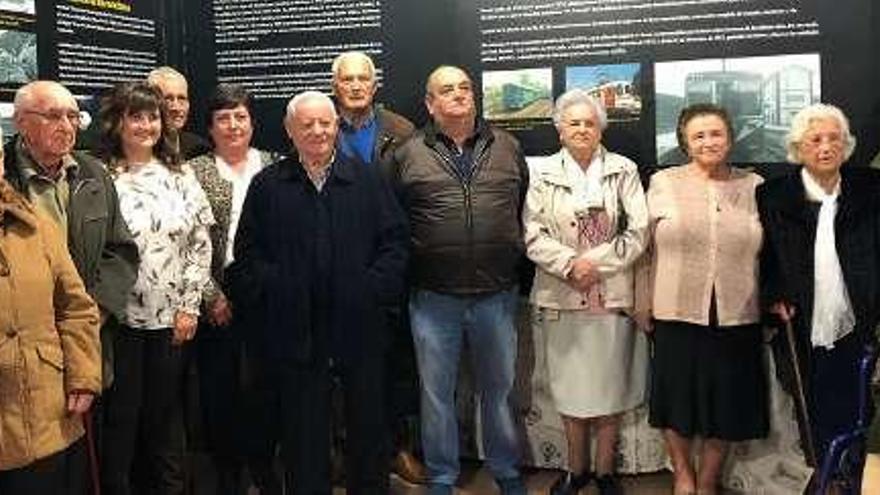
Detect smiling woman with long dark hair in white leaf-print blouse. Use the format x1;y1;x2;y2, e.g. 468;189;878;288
99;82;214;495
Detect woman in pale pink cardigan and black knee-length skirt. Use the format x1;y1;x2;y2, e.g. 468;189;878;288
648;104;769;494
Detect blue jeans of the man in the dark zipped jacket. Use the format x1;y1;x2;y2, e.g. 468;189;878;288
410;288;520;486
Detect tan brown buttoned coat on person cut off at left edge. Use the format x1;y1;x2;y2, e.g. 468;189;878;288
0;179;101;470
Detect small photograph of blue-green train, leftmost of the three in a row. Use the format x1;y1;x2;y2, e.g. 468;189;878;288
483;68;553;121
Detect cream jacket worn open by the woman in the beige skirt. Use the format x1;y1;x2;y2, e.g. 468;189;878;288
523;147;648;311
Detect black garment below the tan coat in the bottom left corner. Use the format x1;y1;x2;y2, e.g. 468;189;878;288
0;438;88;495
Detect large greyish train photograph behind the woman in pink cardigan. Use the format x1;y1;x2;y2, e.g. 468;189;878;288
654;53;821;165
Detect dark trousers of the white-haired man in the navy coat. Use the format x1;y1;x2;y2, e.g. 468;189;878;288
275;355;388;495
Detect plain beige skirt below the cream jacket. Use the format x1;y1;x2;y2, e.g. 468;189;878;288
535;308;648;418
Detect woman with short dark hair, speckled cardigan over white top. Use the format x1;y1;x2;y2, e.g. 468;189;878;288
187;84;280;495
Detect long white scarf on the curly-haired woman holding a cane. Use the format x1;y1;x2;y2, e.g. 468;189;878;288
801;169;856;349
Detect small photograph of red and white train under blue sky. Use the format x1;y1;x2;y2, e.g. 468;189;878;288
565;64;642;121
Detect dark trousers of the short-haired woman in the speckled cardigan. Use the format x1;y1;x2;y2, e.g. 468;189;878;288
196;321;280;495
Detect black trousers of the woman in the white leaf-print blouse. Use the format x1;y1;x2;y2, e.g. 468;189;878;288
101;327;186;495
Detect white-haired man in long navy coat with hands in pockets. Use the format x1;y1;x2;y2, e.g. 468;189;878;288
228;91;408;494
